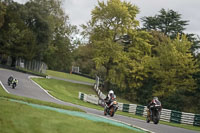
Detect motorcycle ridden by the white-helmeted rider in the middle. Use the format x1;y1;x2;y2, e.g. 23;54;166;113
104;98;118;117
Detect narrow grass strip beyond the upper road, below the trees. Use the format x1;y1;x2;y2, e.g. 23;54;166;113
46;70;95;83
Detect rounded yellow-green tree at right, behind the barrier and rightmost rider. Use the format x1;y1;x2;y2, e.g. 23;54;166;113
151;36;199;110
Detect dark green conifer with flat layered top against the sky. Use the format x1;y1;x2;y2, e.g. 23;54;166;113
142;9;188;39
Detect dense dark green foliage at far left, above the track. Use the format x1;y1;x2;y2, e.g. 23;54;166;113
0;0;76;70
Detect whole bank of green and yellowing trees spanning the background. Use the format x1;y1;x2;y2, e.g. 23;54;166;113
0;0;200;113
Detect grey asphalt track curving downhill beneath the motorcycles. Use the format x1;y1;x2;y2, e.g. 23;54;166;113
0;68;199;133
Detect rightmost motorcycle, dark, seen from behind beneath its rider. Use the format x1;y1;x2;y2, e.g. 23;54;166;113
146;104;161;124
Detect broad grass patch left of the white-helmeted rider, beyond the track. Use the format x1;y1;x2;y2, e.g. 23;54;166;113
33;78;103;110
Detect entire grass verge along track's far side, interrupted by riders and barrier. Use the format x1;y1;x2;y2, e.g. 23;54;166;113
33;78;200;131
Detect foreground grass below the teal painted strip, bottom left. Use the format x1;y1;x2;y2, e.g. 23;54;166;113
0;99;140;133
